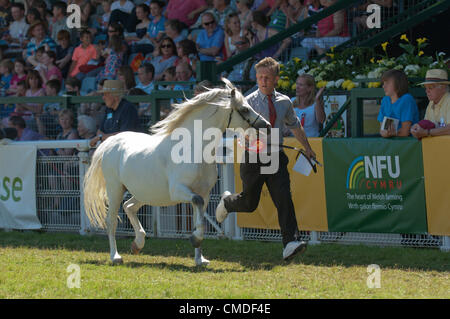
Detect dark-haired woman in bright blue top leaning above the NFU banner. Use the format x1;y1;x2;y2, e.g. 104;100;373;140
378;70;419;137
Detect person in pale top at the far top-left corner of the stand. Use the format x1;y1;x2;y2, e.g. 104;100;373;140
0;3;29;56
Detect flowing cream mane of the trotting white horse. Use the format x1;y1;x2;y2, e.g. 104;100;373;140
150;79;239;135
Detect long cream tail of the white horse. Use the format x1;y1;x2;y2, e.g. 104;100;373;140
84;143;108;228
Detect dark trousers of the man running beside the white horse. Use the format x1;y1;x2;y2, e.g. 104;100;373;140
224;152;298;246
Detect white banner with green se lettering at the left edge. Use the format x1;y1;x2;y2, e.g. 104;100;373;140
0;144;42;229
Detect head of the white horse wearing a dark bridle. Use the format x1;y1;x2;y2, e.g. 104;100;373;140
222;79;271;129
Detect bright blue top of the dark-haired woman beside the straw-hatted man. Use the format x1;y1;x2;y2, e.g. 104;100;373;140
378;93;419;129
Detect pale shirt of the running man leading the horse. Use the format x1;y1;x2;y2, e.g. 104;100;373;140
246;89;301;144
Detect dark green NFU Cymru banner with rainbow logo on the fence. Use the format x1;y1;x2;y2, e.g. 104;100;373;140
323;138;427;234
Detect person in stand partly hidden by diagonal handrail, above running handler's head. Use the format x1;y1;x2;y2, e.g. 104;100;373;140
247;11;292;60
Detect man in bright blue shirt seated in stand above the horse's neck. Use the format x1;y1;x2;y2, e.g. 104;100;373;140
196;11;225;61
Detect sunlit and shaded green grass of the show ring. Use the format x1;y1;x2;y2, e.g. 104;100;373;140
0;231;450;299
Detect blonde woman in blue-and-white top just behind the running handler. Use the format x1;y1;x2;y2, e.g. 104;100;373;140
292;74;325;137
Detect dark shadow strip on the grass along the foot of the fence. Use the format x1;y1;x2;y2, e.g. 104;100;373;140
0;231;450;272
